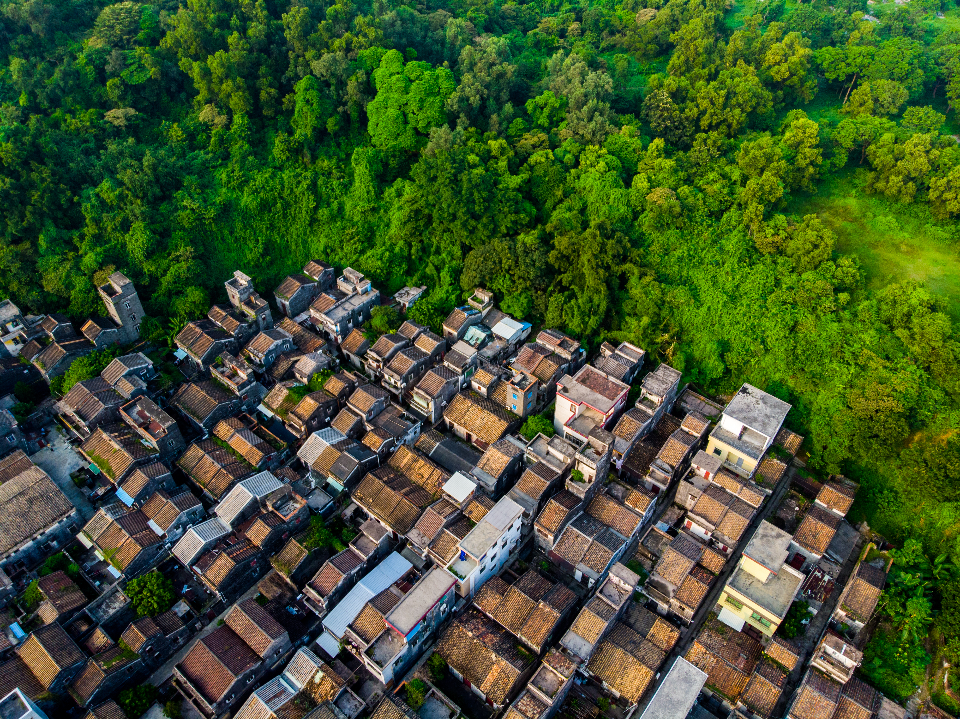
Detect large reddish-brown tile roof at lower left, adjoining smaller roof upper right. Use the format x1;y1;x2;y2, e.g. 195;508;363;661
177;624;260;703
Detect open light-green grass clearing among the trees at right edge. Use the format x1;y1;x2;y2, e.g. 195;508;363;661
788;169;960;320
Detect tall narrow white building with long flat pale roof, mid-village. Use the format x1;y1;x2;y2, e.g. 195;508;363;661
447;497;523;597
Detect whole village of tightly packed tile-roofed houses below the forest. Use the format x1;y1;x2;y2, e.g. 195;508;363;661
0;260;947;719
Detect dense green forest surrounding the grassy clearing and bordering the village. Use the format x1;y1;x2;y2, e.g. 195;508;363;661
0;0;960;701
